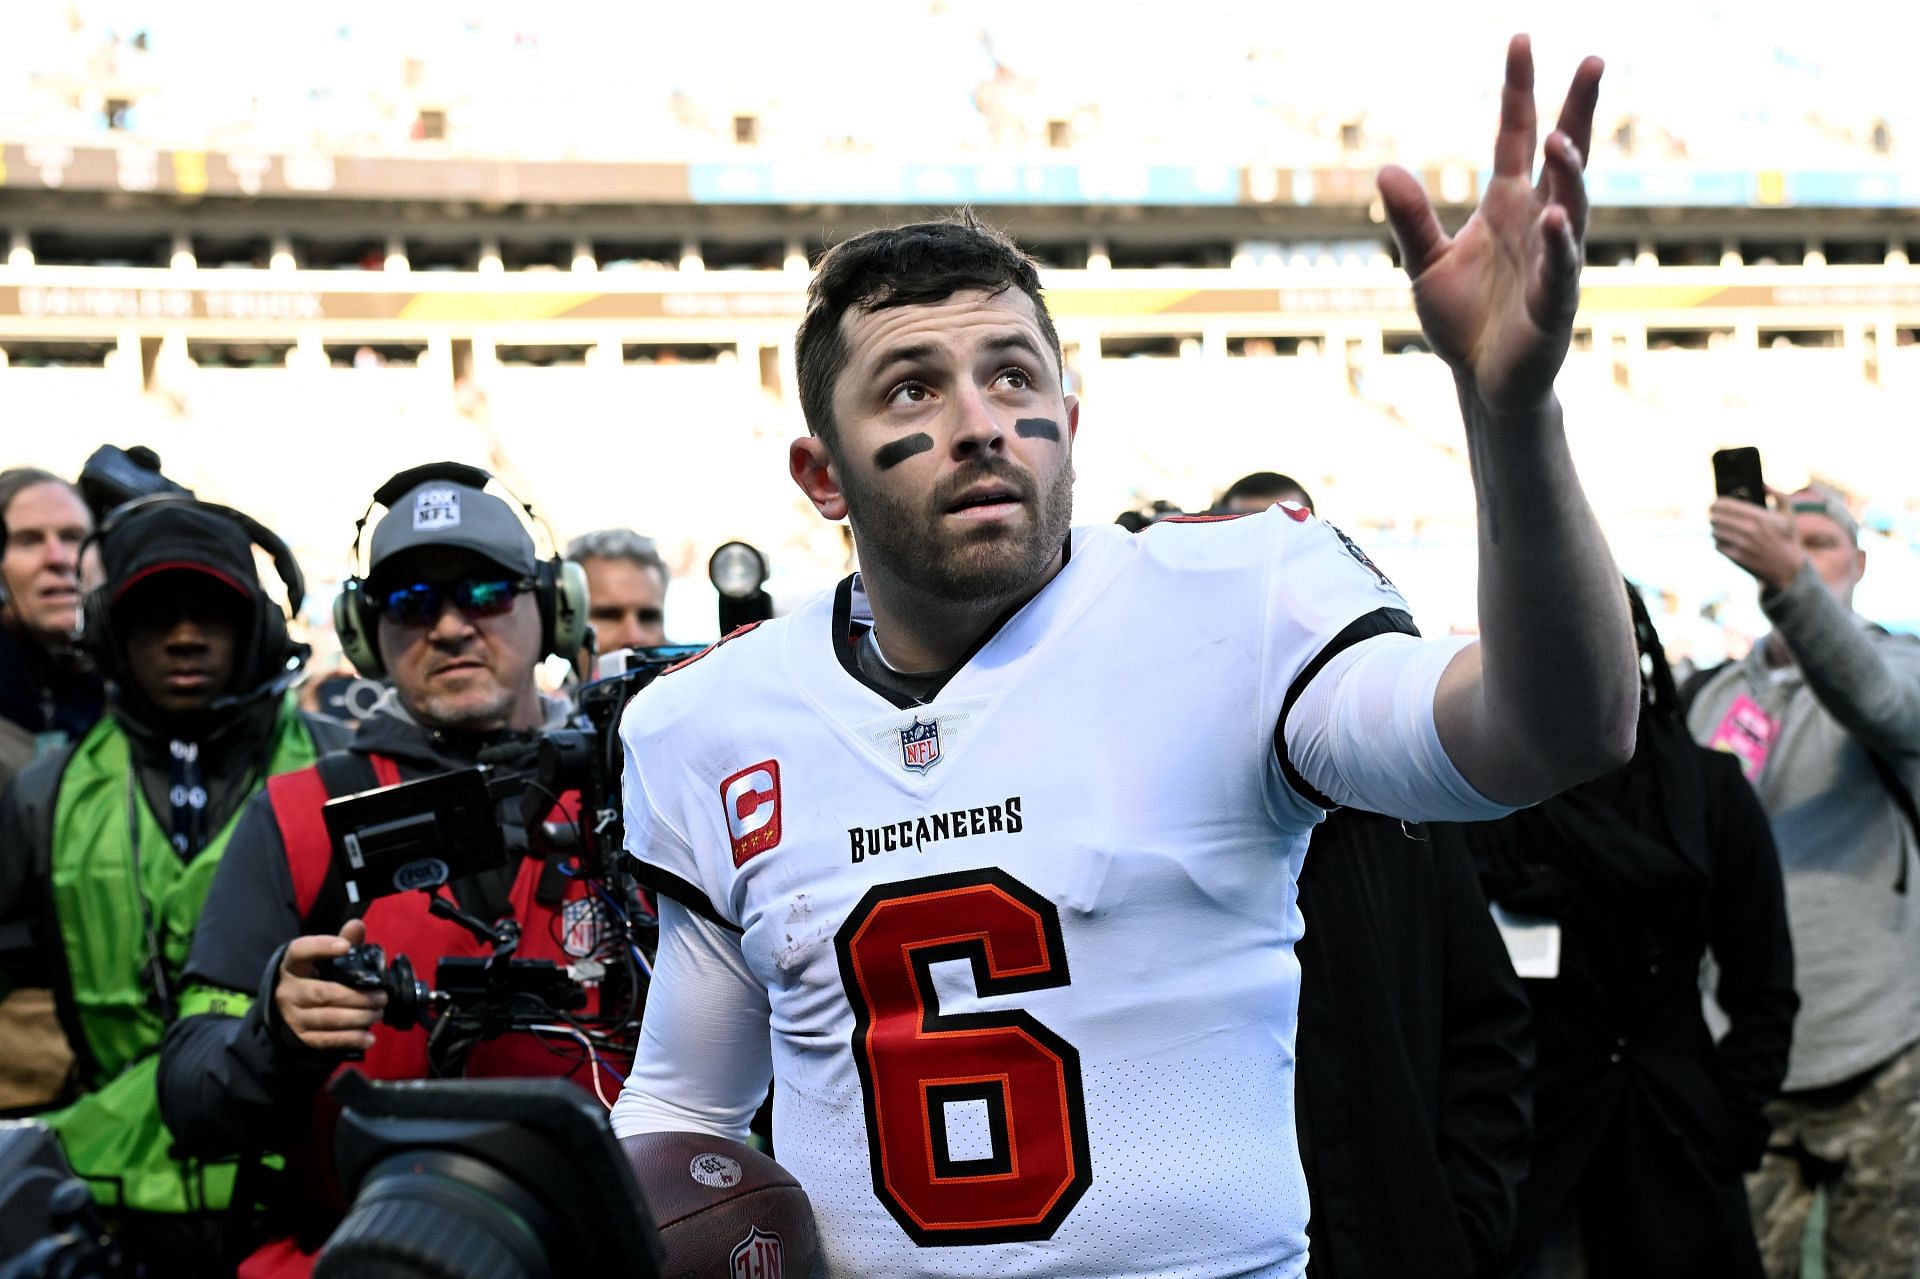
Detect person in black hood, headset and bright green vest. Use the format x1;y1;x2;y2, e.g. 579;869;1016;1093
0;489;346;1275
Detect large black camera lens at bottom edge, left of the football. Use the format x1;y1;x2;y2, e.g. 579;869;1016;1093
313;1150;553;1279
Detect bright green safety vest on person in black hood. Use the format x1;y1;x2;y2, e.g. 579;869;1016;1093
40;695;317;1212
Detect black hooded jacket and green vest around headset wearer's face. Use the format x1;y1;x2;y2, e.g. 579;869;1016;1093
0;503;346;1214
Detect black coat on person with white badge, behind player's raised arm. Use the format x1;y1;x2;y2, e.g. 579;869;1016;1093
1467;711;1799;1275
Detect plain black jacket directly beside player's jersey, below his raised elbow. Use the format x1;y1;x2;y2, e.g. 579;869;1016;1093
1294;810;1534;1279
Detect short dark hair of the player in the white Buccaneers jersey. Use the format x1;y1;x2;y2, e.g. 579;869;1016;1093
795;209;1066;444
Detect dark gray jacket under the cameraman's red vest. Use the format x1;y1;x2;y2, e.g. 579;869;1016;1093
159;693;560;1158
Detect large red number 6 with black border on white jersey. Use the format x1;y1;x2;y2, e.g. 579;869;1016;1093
833;870;1092;1246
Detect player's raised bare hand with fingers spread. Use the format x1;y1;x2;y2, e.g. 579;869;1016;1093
1380;35;1601;417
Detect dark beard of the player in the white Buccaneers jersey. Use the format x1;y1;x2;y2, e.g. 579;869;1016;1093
841;457;1073;603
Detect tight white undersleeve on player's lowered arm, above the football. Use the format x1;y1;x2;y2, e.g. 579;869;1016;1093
612;899;774;1141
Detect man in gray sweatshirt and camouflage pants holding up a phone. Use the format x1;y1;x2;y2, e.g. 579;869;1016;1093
1688;484;1920;1279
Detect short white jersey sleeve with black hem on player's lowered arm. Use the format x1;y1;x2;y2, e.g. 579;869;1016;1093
620;689;741;933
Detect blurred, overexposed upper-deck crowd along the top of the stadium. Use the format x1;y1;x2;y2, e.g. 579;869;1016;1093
0;0;1920;169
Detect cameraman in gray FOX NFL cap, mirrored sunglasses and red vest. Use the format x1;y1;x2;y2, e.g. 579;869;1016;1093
159;465;626;1277
